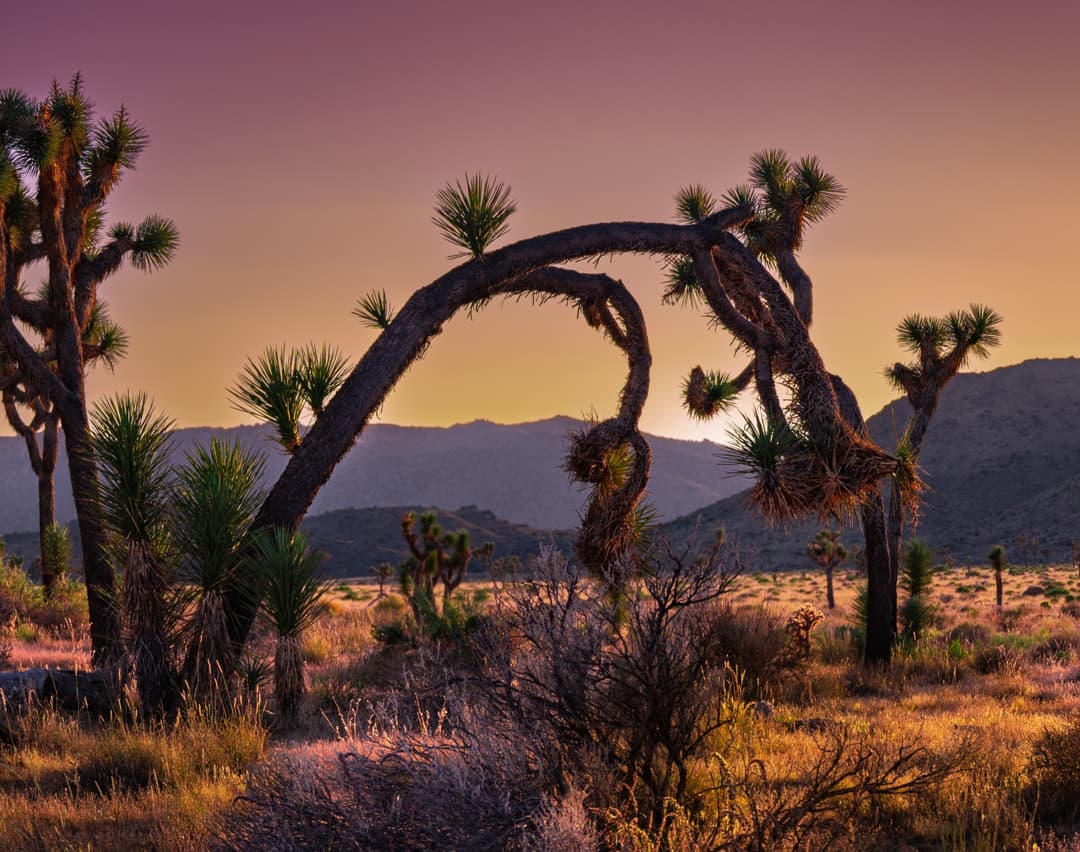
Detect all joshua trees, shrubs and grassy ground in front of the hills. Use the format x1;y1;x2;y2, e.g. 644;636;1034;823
0;77;1080;850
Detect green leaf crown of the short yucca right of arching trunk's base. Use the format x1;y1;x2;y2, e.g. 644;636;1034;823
253;527;330;636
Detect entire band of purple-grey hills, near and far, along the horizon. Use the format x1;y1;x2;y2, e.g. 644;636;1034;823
8;359;1080;576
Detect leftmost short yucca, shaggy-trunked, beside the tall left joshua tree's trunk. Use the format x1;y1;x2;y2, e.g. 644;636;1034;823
91;393;173;713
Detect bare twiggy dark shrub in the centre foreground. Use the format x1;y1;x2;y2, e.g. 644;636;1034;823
475;544;743;826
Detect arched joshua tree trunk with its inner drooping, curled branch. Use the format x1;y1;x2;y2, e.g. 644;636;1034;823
227;258;673;646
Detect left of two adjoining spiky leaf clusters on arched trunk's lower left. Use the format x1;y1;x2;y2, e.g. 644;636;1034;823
229;346;305;452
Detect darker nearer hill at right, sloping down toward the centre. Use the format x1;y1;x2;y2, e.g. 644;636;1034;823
665;359;1080;567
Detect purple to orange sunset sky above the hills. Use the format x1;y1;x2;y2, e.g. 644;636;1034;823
0;0;1080;441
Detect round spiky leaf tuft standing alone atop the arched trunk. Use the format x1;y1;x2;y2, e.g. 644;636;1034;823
432;174;517;258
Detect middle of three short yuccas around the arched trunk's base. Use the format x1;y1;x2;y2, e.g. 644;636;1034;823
173;438;265;694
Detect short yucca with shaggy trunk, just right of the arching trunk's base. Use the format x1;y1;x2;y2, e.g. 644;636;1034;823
253;527;329;726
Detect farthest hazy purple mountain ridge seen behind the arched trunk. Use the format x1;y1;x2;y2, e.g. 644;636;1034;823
0;417;744;531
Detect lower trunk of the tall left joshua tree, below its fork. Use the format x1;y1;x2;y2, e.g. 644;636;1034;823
63;404;120;666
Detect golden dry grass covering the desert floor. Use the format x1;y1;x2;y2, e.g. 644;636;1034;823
0;566;1080;850
